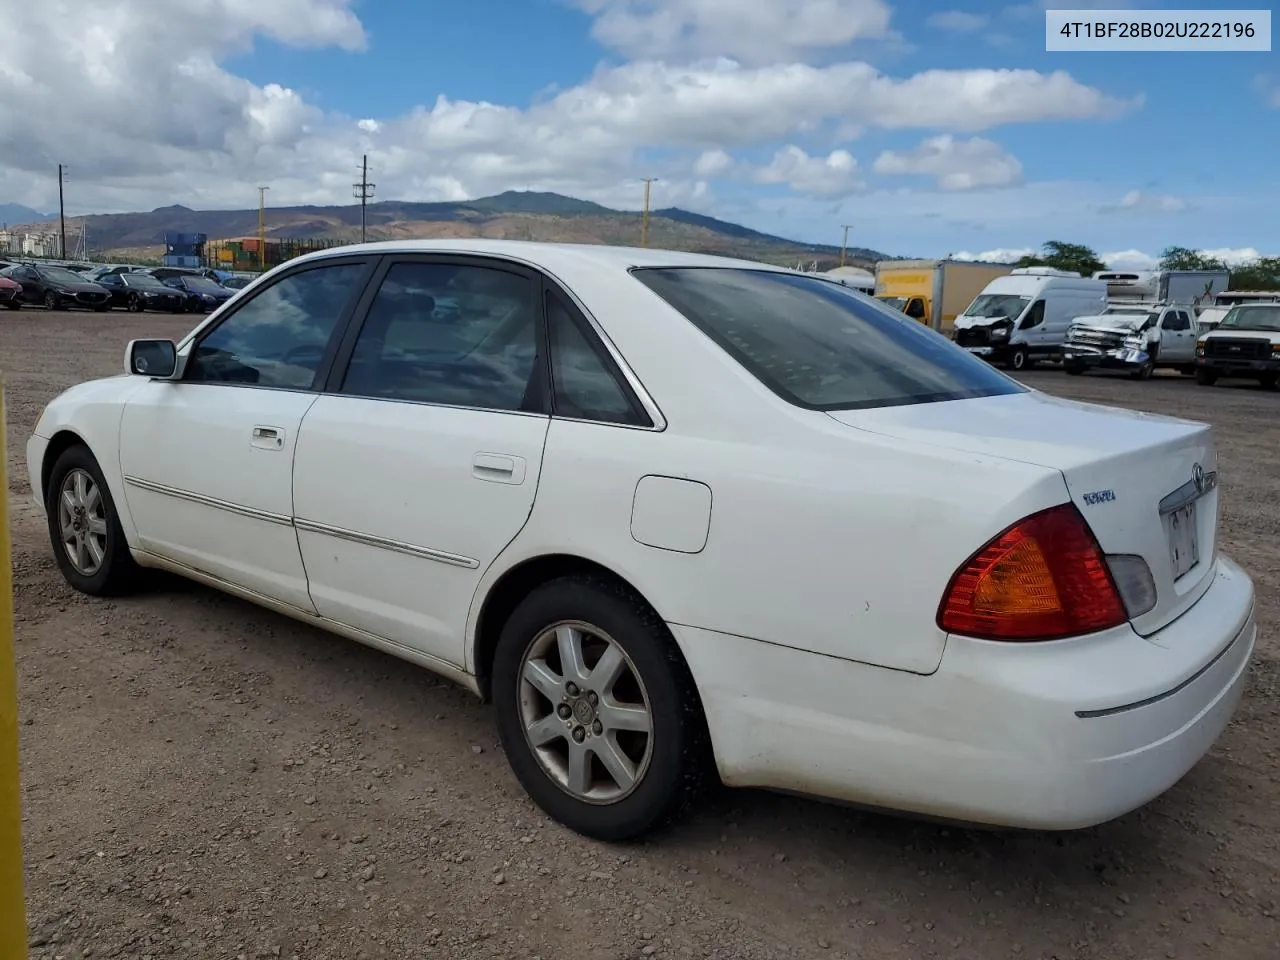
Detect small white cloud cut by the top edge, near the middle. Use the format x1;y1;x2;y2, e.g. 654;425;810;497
572;0;892;64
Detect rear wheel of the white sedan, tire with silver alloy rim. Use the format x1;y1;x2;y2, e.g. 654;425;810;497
493;576;710;842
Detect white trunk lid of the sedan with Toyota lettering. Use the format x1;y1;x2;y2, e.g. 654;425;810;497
828;392;1219;636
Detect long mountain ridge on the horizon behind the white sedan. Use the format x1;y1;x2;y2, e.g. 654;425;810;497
7;191;886;268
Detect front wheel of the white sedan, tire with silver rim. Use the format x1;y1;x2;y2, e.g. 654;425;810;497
45;444;141;596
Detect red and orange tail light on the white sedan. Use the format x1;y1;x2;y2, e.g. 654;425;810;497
938;503;1128;640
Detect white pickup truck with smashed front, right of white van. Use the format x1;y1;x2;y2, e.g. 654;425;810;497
1062;301;1197;380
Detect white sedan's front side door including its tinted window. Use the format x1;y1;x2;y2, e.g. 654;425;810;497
120;257;376;612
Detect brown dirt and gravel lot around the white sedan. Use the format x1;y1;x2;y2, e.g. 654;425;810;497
0;311;1280;960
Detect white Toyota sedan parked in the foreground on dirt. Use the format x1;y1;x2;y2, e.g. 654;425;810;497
27;241;1256;840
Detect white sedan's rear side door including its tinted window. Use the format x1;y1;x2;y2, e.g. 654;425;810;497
293;256;549;667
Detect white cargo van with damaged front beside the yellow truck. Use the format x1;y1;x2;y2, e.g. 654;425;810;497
955;266;1107;370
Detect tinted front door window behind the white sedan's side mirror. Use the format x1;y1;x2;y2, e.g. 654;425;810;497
183;264;365;389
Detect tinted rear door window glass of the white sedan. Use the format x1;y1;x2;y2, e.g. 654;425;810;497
342;262;541;410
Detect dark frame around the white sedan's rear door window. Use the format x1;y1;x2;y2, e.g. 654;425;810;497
319;253;550;417
